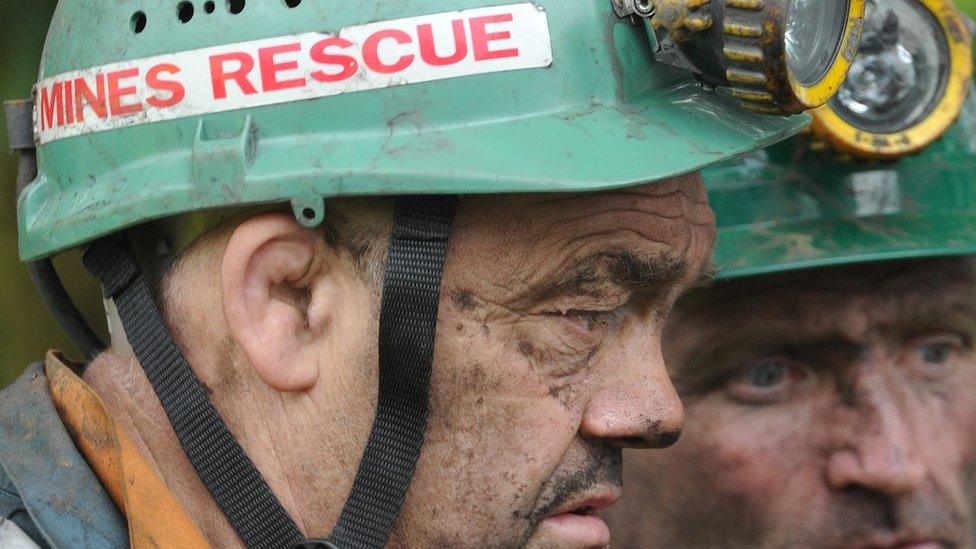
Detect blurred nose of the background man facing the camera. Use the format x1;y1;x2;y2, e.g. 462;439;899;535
827;374;926;497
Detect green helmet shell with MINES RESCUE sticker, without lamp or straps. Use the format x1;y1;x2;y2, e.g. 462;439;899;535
18;0;856;260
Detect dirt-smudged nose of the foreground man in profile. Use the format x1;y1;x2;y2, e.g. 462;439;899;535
580;344;685;448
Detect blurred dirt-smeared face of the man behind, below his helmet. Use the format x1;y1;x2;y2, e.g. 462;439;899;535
611;259;976;548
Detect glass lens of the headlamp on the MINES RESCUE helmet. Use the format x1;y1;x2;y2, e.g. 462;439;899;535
785;0;851;86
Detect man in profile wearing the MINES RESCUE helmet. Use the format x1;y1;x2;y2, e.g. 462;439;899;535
0;0;857;548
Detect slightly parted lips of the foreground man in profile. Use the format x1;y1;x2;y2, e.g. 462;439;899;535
541;489;620;547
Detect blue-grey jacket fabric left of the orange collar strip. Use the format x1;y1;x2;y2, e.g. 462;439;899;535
0;364;129;549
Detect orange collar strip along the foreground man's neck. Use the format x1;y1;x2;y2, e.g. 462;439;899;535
45;353;210;549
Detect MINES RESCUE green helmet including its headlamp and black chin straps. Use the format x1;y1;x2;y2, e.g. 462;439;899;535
7;0;863;547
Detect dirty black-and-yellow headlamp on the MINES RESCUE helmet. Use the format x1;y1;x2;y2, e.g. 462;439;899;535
613;0;865;114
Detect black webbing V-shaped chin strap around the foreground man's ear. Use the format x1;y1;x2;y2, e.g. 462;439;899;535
84;197;457;549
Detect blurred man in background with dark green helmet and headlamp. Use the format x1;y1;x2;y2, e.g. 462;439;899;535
611;1;976;548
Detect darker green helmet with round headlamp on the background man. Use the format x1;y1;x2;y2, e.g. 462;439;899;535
704;0;976;279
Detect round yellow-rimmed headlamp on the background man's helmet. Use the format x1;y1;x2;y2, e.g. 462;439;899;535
812;0;973;159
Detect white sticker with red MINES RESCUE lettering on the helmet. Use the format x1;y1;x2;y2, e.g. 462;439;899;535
34;4;552;145
